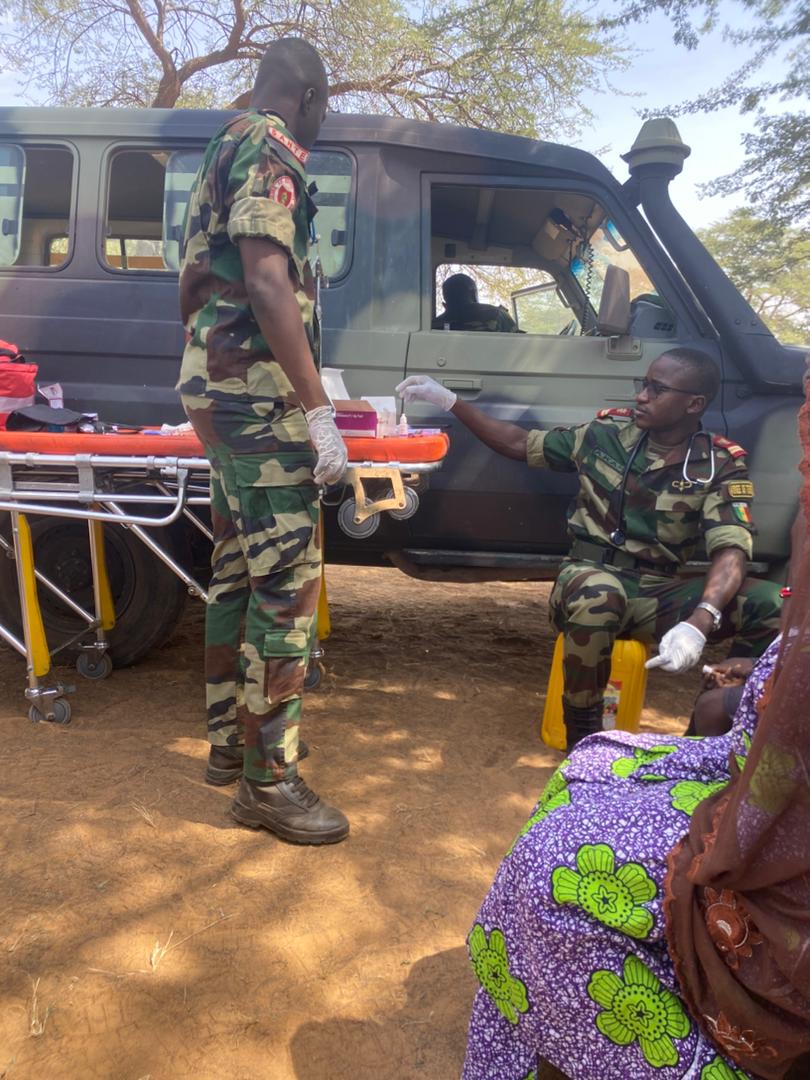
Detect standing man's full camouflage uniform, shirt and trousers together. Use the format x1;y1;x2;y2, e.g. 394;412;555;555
177;112;321;783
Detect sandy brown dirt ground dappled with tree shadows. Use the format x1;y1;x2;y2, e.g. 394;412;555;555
0;568;697;1080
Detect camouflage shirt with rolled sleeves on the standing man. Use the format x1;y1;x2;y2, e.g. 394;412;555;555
177;111;315;408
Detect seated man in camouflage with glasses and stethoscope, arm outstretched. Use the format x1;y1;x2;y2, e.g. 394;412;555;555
397;349;780;748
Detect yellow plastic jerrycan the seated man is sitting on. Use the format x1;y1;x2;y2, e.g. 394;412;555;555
540;634;649;750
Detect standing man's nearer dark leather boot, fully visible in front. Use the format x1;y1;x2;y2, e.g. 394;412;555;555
231;777;349;843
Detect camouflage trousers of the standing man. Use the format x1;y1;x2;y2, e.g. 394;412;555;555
183;396;321;783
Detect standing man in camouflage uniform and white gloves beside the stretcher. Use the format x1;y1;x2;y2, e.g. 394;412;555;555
178;38;349;843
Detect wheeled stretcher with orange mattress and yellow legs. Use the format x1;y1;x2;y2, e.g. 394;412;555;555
0;430;449;724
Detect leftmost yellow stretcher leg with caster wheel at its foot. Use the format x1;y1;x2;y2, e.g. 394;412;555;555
11;510;72;724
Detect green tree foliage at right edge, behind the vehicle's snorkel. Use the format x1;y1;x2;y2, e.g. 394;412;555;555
699;210;810;345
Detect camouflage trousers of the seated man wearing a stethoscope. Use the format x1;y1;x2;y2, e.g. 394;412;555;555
549;562;782;708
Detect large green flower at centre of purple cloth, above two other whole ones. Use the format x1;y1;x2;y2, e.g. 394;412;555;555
551;843;658;939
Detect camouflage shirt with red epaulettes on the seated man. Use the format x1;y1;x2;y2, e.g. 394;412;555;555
526;409;754;564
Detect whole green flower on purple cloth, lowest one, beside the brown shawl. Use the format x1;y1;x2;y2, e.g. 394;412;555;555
588;955;690;1069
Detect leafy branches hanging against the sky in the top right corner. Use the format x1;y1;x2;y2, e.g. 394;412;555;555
603;0;810;224
